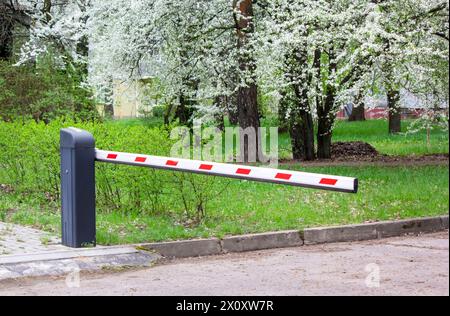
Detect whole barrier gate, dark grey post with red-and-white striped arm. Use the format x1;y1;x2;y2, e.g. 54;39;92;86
61;128;358;248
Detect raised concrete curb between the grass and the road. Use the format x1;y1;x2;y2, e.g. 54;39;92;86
136;216;449;258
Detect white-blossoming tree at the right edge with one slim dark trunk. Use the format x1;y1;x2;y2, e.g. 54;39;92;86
371;0;449;133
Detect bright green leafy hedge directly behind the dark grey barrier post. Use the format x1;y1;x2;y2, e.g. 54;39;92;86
0;119;225;224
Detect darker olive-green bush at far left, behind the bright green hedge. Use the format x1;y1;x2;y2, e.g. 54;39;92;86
0;58;98;123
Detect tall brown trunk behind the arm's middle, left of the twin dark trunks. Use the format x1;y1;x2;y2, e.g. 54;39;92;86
233;0;263;162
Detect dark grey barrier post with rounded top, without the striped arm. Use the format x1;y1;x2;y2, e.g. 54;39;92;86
61;128;96;248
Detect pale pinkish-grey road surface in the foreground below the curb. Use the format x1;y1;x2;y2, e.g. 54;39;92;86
0;233;449;296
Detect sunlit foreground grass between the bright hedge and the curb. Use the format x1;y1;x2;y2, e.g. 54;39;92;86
0;166;449;244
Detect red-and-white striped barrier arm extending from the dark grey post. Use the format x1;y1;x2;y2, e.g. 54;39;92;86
96;150;358;193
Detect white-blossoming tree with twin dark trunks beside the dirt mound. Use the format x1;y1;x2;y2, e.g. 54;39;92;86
258;0;375;160
